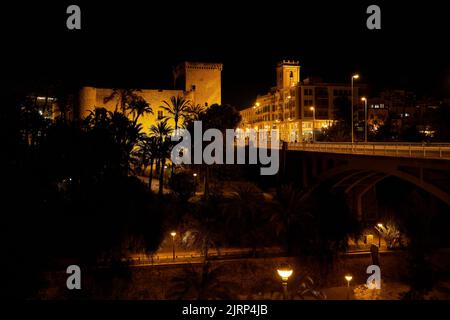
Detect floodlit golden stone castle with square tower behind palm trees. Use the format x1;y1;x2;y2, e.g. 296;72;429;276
78;62;222;129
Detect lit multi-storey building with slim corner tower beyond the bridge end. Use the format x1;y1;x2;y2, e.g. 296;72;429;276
241;60;361;142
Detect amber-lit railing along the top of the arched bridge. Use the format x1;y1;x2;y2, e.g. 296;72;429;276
288;142;450;159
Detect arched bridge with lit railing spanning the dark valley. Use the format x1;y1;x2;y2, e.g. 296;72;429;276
280;143;450;219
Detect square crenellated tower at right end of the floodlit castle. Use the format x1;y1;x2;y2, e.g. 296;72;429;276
174;62;222;107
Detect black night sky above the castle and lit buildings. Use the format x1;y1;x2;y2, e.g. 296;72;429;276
0;0;450;107
